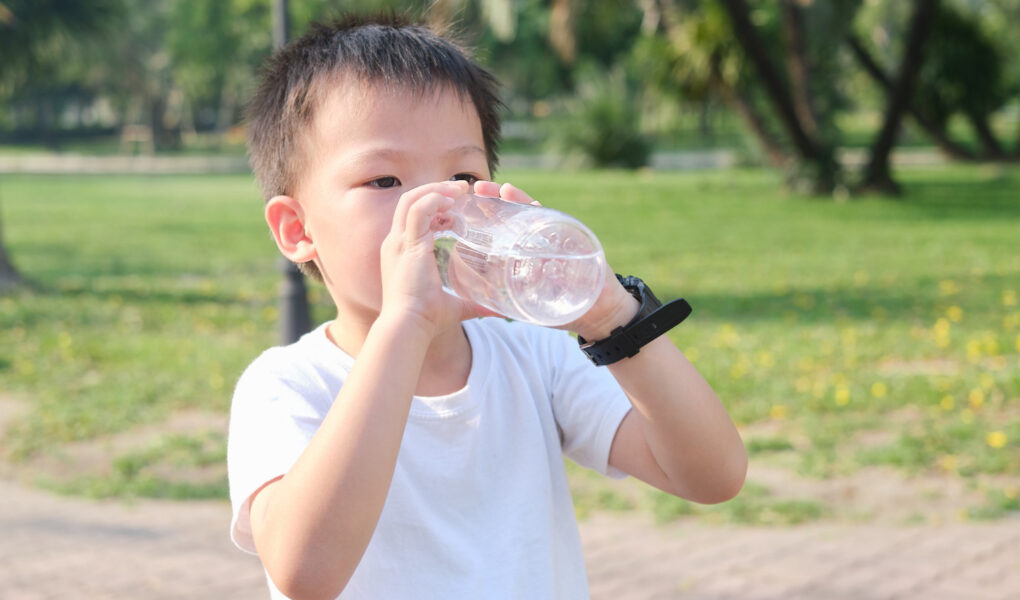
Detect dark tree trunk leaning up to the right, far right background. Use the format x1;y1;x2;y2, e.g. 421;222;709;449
860;0;938;194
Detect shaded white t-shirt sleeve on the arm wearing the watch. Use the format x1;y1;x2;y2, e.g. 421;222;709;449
550;332;630;478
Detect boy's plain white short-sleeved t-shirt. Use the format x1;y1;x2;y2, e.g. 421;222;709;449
227;317;630;600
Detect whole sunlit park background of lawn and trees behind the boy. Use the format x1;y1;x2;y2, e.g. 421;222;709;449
0;0;1020;595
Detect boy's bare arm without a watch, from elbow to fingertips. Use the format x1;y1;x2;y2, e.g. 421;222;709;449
250;182;469;599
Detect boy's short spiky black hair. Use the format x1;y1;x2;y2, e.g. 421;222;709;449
248;13;503;280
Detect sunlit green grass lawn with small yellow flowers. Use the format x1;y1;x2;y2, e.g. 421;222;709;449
0;167;1020;522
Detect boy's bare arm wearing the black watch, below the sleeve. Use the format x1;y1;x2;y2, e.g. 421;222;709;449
574;283;748;503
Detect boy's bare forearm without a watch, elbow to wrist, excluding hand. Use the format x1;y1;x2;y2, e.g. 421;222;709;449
251;318;428;598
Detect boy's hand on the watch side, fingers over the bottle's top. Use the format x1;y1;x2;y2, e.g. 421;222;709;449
474;182;641;342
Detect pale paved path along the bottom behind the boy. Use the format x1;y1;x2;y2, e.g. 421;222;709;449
0;481;1020;600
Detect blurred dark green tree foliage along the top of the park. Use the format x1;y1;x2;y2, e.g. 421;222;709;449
0;0;1020;193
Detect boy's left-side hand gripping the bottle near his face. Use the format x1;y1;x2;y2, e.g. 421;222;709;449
379;182;492;335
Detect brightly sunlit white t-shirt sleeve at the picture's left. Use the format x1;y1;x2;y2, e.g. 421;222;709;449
226;350;323;554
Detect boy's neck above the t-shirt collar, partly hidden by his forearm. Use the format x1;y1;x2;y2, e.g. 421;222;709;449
326;317;472;396
